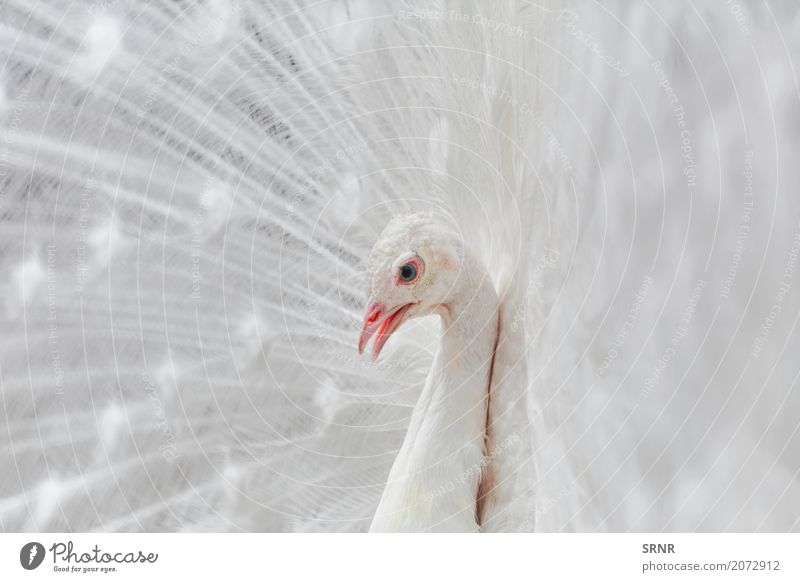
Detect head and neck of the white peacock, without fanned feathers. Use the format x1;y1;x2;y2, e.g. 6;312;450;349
359;215;498;532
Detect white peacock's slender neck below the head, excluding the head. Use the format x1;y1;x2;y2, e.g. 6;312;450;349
370;260;498;532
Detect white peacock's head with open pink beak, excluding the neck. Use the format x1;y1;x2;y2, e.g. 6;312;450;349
358;213;464;359
